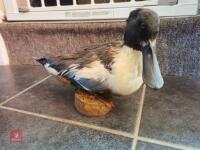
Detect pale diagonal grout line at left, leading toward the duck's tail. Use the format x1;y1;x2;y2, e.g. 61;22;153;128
0;75;51;106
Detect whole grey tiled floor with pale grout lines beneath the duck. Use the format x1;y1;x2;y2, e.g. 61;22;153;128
0;66;200;150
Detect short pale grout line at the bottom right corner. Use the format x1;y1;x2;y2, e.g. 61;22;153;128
137;136;198;150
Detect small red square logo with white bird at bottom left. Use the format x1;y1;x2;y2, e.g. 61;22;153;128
9;129;23;143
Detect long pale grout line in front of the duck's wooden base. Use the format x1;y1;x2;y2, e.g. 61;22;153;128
0;106;134;139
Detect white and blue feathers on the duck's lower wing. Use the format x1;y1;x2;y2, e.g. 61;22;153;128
62;61;109;92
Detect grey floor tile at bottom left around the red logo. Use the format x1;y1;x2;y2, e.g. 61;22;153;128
0;109;132;150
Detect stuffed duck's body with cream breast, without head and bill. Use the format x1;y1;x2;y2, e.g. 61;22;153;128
38;42;143;95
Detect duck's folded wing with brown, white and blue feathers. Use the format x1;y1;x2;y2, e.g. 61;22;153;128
38;42;123;92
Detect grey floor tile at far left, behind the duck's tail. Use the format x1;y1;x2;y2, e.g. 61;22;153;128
0;65;47;102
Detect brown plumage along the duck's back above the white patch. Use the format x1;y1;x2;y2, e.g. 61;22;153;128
43;41;123;71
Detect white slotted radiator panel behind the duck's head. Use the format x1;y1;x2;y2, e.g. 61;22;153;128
1;0;198;21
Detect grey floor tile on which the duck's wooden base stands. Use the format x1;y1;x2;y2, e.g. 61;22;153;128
3;77;141;132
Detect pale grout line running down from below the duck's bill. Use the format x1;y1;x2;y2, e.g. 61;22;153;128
131;84;146;150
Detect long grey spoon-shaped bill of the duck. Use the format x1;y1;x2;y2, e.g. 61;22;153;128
142;42;164;89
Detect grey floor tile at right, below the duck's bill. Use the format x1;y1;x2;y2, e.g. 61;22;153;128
140;77;200;148
